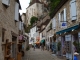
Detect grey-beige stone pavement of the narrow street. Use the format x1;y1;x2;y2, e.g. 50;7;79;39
23;48;65;60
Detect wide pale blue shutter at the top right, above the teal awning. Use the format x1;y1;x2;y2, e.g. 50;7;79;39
70;0;77;20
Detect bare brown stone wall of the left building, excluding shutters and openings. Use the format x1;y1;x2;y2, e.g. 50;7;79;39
0;0;18;60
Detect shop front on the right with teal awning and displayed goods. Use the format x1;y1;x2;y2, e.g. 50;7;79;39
56;25;80;60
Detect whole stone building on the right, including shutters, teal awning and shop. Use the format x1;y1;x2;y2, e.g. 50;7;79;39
52;0;80;60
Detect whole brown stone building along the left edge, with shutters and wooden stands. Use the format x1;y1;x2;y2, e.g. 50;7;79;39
0;0;21;60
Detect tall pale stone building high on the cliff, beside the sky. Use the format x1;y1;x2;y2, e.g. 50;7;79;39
26;0;44;25
